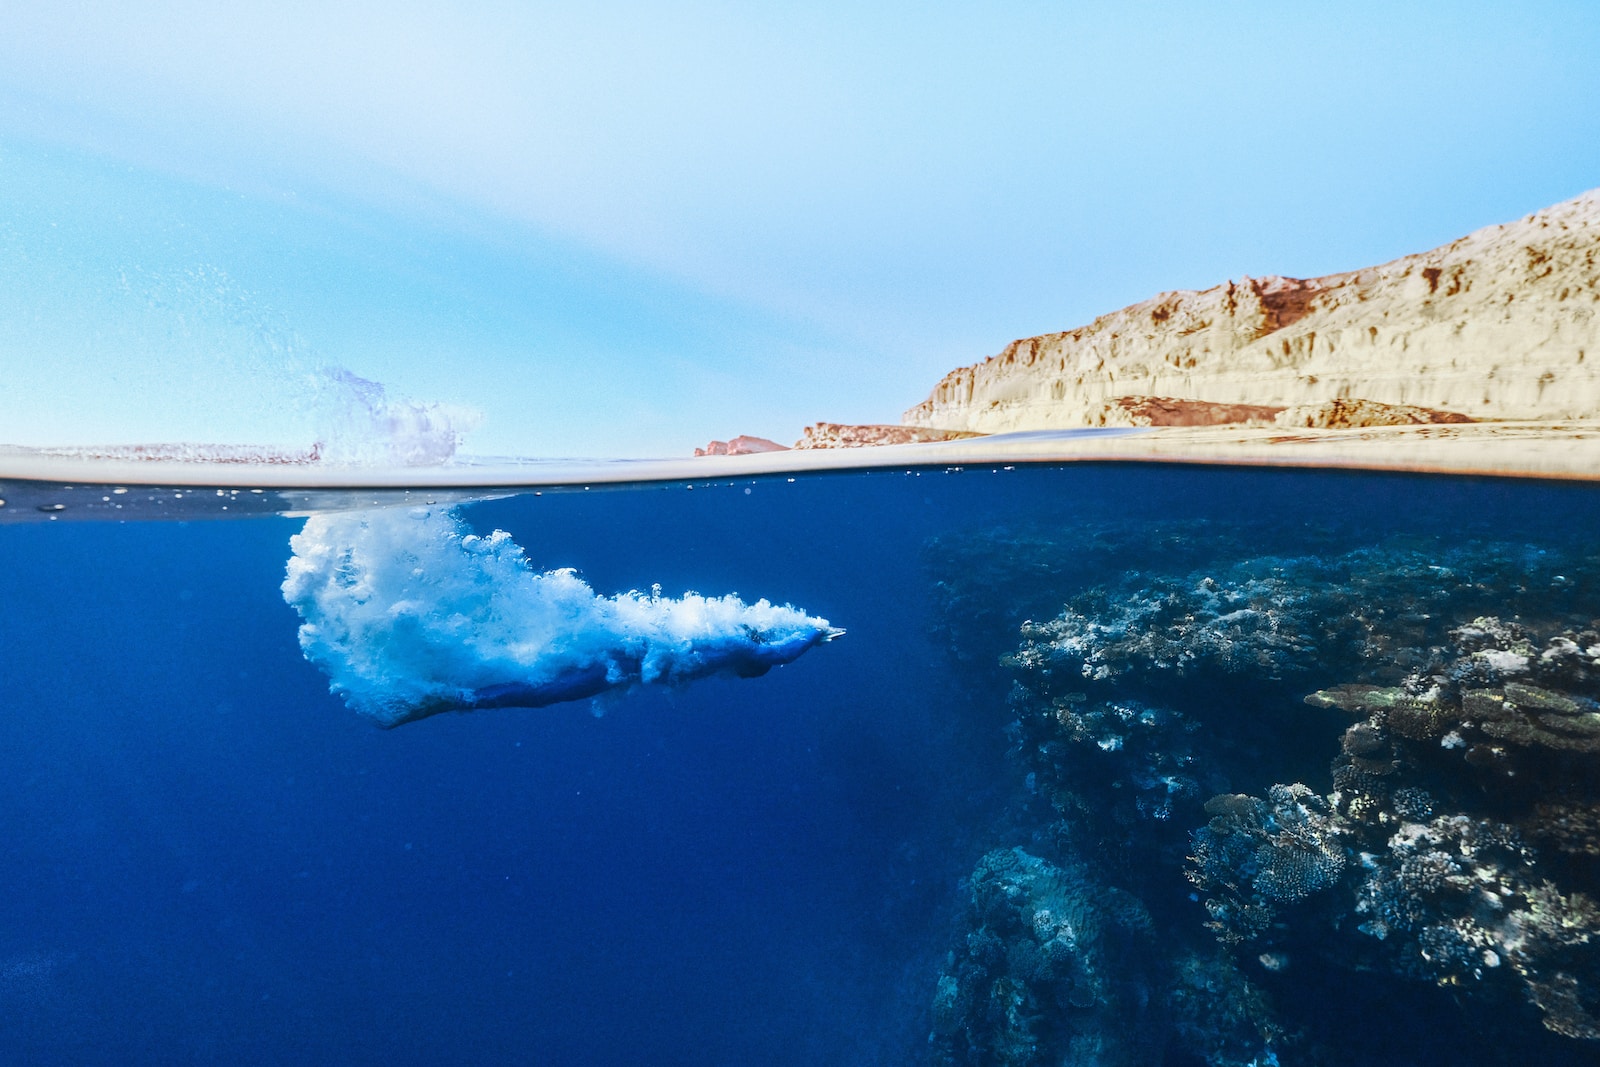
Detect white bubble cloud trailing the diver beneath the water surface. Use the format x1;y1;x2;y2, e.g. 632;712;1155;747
283;507;843;726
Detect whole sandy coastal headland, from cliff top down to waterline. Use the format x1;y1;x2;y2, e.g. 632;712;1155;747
698;189;1600;477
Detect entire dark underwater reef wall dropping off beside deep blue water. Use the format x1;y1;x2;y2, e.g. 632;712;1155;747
934;528;1600;1067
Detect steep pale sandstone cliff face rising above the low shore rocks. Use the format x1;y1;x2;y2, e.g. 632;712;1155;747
904;190;1600;434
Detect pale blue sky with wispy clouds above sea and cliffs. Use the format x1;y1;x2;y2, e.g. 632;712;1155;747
0;0;1600;454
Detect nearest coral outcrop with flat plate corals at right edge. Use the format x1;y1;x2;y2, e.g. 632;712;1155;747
1306;616;1600;1040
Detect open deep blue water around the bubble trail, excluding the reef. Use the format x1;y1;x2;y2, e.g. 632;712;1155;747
0;466;1600;1065
